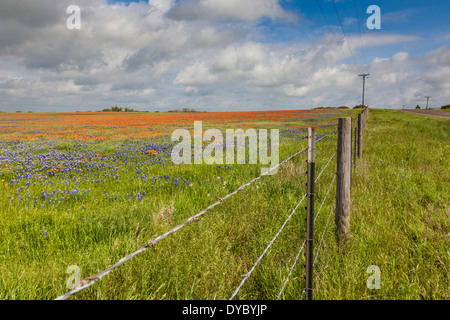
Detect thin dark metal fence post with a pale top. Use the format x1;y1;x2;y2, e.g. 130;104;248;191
305;128;316;300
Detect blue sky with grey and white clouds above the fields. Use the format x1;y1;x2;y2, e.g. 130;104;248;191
0;0;450;112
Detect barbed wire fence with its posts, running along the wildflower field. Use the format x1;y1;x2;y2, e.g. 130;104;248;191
55;109;368;300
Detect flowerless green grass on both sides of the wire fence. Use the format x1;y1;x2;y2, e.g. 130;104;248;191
0;110;450;300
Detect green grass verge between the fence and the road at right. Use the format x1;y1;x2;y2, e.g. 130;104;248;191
317;110;450;300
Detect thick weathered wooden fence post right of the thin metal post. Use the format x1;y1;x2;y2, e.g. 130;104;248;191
335;118;352;242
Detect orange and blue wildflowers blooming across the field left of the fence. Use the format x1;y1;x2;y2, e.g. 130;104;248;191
0;111;342;218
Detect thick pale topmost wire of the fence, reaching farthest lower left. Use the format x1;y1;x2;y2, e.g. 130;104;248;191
55;131;336;300
